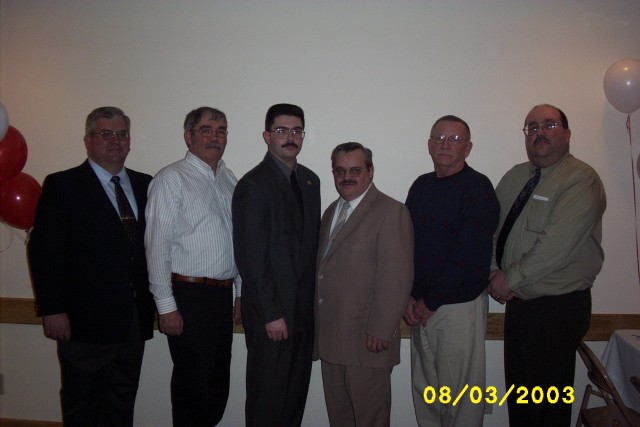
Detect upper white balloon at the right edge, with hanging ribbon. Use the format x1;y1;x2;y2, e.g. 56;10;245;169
603;58;640;114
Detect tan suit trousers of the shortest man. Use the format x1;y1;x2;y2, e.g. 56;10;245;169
322;361;393;427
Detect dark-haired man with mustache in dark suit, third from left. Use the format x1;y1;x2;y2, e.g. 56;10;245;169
232;104;320;427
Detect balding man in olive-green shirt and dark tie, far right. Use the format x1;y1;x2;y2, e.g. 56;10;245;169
488;104;606;426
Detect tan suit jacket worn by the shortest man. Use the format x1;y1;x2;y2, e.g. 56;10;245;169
314;184;413;367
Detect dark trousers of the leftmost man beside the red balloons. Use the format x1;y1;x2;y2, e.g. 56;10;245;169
58;315;144;427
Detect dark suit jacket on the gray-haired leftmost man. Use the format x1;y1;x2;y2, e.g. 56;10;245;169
28;161;155;344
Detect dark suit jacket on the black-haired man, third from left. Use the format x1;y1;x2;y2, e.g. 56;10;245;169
231;153;320;332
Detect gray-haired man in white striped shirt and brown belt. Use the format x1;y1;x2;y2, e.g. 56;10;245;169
145;107;242;427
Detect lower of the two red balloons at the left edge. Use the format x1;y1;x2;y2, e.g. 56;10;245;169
0;172;42;230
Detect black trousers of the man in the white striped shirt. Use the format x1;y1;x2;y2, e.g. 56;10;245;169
167;282;233;427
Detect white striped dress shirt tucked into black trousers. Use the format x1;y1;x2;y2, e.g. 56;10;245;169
144;152;242;314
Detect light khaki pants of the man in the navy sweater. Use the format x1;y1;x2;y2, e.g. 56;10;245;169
411;292;489;427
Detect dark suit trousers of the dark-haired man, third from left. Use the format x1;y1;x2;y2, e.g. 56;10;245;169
245;329;313;427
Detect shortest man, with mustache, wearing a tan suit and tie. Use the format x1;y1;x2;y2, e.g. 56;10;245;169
314;142;413;427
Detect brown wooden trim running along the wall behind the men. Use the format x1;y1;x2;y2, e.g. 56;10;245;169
0;297;640;341
